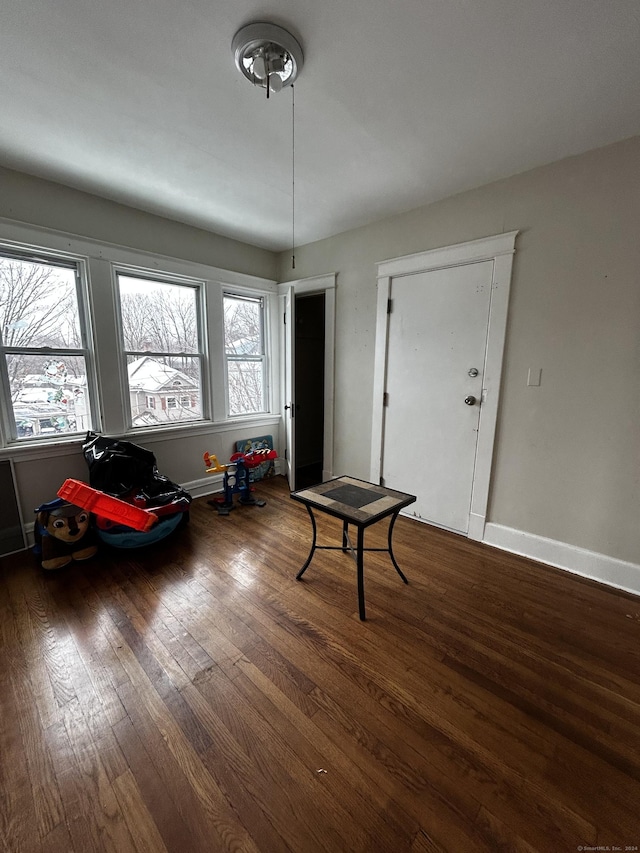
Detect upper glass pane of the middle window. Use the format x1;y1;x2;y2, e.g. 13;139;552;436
118;274;198;353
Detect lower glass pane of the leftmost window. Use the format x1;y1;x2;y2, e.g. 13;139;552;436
6;354;91;438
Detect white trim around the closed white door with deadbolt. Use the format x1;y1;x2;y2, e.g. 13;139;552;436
369;231;518;541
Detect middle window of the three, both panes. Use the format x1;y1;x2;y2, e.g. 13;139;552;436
116;271;204;427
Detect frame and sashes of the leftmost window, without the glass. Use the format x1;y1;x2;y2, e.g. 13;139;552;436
0;239;102;448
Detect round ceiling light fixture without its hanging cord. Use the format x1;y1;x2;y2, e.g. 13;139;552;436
231;22;304;92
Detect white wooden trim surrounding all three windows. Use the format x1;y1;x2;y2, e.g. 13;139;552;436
0;218;280;460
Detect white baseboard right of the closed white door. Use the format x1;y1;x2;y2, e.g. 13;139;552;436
482;522;640;595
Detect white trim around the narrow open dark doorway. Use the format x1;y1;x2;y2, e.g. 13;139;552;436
278;273;337;480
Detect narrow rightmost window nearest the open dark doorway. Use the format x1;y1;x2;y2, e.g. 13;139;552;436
224;294;266;415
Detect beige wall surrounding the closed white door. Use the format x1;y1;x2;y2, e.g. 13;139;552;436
279;138;640;590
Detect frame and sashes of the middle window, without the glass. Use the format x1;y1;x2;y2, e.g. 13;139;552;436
112;264;212;433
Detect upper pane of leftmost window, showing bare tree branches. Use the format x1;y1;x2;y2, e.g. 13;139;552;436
0;258;82;349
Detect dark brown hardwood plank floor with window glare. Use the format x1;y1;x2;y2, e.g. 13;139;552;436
0;478;640;853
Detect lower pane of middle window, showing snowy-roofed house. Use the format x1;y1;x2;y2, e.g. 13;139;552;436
127;356;202;427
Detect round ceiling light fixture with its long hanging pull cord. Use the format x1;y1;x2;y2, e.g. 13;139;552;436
231;22;304;269
